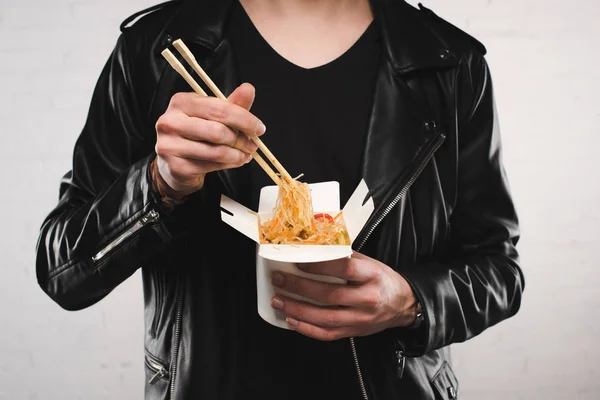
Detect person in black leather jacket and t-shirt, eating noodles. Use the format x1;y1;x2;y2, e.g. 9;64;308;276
37;0;524;400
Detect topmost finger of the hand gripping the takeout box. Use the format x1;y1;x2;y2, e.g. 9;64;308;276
296;253;378;283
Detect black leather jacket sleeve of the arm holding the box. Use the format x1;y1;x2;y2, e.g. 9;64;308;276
398;56;524;356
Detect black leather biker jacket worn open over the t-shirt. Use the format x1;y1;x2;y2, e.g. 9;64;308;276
37;0;524;400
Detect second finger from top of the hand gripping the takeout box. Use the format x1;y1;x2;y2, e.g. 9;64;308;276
272;272;378;310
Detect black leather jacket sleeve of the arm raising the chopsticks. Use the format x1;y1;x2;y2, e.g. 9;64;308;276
36;34;188;310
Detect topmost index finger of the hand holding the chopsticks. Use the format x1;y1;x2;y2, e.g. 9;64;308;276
169;93;266;136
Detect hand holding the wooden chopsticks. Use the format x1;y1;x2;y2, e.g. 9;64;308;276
156;83;265;198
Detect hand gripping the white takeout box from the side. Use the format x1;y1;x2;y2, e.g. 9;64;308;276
271;252;417;341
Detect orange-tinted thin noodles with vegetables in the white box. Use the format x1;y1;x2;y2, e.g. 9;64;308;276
259;180;350;245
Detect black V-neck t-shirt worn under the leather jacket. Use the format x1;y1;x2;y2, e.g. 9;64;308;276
226;4;380;400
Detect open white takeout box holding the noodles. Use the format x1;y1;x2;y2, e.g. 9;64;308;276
221;180;375;329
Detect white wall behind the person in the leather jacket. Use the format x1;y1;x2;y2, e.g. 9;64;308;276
0;0;600;400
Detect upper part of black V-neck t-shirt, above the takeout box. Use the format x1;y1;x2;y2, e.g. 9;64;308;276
228;5;380;206
